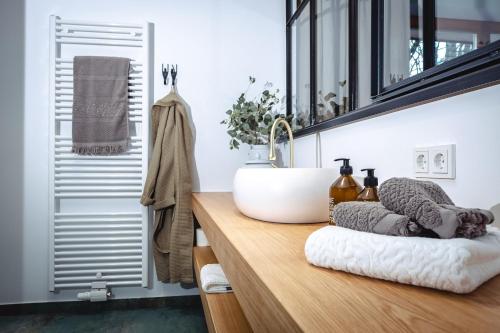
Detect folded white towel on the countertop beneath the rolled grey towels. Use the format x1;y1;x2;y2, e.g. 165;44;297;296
305;226;500;293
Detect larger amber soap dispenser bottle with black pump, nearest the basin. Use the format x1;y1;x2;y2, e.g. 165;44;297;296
329;158;362;225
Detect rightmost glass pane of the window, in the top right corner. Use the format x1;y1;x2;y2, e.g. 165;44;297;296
436;0;500;65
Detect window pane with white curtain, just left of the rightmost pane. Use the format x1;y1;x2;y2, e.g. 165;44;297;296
383;0;424;87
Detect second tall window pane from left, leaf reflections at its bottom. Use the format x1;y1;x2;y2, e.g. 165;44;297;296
316;0;349;122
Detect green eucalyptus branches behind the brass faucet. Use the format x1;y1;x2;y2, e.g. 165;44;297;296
221;76;293;149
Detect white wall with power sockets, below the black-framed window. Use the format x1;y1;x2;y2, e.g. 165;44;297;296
295;85;500;216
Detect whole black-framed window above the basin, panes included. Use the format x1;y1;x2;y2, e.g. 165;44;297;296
286;0;500;136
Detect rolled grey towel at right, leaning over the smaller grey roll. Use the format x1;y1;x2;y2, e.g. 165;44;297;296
379;178;494;238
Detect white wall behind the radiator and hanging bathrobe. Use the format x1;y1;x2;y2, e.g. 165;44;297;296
0;0;285;303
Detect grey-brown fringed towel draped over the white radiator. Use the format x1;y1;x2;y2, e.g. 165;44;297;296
73;57;130;155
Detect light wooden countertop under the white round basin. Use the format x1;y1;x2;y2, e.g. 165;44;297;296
193;193;500;332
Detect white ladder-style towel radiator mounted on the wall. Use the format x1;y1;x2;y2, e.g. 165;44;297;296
49;16;152;291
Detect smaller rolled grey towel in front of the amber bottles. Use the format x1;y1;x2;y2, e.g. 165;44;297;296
332;201;422;236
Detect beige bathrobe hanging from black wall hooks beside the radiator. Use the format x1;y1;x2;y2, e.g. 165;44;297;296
141;91;193;283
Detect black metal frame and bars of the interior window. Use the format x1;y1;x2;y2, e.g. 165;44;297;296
286;0;500;137
